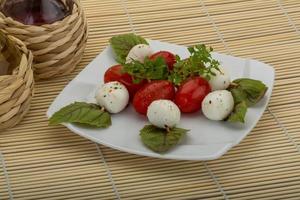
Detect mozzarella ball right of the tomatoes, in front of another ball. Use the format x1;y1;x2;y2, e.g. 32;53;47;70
202;90;234;121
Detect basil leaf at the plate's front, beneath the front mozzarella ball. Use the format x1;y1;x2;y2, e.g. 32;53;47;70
140;125;188;153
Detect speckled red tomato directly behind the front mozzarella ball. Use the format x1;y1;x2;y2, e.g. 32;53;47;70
133;80;175;115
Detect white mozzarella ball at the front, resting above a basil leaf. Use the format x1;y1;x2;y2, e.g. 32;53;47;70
147;100;180;128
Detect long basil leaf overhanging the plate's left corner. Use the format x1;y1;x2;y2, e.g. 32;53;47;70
49;102;111;128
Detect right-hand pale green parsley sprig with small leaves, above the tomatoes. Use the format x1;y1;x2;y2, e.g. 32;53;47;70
169;44;220;85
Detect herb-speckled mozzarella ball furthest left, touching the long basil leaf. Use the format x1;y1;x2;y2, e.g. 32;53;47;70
96;81;129;113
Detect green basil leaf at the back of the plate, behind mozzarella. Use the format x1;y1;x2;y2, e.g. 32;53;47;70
109;33;148;64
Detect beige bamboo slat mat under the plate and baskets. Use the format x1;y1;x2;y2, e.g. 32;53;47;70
0;0;300;200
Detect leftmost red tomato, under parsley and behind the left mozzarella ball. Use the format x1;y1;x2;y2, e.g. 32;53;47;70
104;65;146;98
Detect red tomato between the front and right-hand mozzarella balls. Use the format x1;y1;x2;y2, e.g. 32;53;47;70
175;77;211;113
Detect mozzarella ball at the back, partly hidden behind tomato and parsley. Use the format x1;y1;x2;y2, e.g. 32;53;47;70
126;44;153;63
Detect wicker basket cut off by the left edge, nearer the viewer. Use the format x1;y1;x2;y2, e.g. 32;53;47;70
0;31;34;130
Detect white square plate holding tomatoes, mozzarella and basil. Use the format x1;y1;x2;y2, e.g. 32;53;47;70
47;40;275;160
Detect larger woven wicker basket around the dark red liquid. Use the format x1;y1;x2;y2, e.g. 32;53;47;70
0;0;88;79
